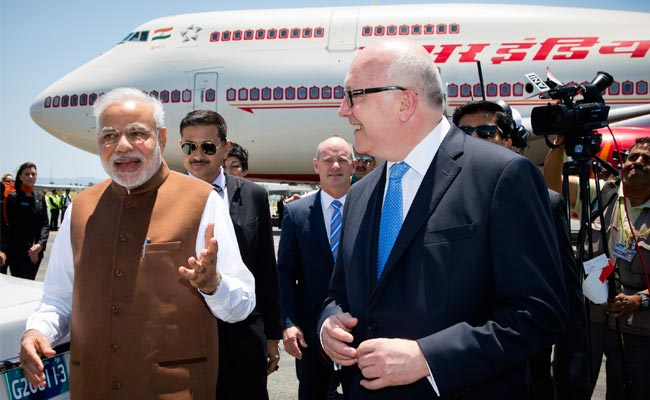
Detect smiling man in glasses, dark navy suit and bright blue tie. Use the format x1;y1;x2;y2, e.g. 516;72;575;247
319;41;566;399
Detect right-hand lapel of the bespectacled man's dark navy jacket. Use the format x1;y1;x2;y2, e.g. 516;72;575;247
375;127;465;293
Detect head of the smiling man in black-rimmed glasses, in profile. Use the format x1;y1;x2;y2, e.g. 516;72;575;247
339;40;445;161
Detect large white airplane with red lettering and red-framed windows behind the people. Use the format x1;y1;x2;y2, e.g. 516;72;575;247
30;4;650;182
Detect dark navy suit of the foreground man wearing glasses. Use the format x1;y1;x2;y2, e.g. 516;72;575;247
321;127;566;399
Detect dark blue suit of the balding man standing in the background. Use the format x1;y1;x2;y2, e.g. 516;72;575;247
278;191;334;399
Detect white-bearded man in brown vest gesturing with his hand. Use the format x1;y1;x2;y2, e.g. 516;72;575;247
20;88;255;399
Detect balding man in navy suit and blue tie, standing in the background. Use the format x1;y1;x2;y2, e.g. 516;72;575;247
278;136;354;400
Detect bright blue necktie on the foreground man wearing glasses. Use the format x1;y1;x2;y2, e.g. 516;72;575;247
377;162;409;280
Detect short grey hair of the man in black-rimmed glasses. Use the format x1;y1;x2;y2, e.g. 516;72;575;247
387;47;446;109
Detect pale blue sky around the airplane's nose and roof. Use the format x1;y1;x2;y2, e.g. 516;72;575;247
0;0;650;183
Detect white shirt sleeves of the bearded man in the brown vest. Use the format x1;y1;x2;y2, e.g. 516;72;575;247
27;191;255;344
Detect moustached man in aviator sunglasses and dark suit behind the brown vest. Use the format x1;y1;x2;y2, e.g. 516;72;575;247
180;110;282;400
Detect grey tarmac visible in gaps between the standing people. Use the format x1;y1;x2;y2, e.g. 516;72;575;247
36;228;605;400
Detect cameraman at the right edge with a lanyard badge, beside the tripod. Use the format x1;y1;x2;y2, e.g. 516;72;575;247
544;136;650;399
